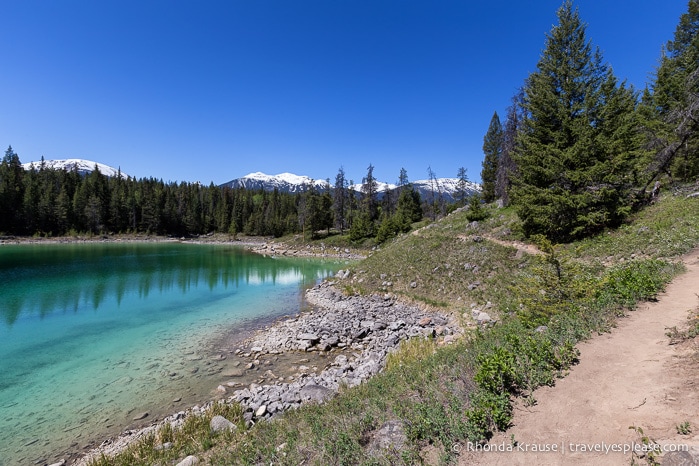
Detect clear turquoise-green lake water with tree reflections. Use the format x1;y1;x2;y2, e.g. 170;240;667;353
0;243;344;466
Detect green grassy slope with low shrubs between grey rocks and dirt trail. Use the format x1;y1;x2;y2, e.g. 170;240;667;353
90;187;699;464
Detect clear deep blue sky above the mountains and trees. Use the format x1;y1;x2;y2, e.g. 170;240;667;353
0;0;687;184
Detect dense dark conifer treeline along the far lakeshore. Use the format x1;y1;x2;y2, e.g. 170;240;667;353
0;153;474;241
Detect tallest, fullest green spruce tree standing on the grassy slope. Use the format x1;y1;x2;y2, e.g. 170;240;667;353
511;1;638;241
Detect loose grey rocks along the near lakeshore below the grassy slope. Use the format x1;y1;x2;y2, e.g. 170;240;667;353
75;278;462;465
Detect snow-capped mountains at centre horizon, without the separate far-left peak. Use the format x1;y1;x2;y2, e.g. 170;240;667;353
221;172;481;202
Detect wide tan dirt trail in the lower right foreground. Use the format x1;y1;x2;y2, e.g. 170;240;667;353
455;248;699;466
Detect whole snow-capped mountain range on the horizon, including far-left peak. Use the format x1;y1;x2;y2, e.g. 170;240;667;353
22;159;481;202
